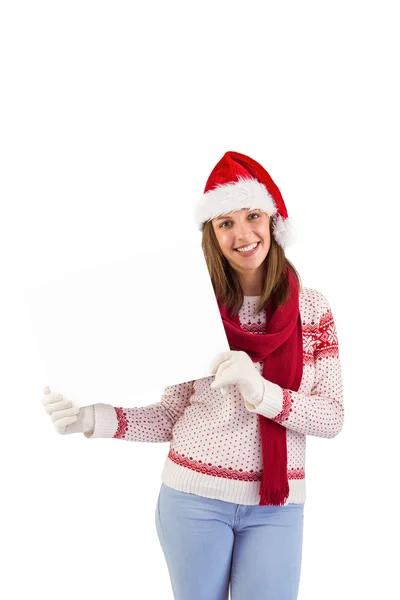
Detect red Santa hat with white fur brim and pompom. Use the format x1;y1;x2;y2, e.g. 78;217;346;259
195;152;296;248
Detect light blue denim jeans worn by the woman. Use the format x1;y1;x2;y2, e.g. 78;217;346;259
155;484;304;600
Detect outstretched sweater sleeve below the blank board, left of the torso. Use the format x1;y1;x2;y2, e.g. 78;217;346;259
84;381;194;442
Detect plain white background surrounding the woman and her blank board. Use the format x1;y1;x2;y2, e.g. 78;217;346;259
0;0;400;600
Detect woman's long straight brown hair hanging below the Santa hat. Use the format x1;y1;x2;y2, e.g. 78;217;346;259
201;218;302;318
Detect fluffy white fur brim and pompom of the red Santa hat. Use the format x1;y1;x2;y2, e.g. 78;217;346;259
195;177;295;248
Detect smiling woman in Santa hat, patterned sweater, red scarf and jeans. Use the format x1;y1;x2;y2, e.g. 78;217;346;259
43;152;344;600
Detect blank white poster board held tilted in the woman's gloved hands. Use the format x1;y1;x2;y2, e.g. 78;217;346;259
25;240;229;407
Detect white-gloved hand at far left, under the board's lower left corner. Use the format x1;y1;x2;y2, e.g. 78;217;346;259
42;387;94;434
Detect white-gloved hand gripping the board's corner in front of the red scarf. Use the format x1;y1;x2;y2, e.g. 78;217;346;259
210;350;266;406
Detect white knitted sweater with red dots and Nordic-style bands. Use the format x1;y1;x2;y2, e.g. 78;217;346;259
84;288;344;505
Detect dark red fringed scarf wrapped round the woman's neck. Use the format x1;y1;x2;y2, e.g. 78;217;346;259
218;268;303;506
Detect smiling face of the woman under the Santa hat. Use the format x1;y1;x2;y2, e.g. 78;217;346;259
212;208;271;276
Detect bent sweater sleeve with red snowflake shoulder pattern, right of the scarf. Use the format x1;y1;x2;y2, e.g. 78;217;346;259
246;293;344;438
